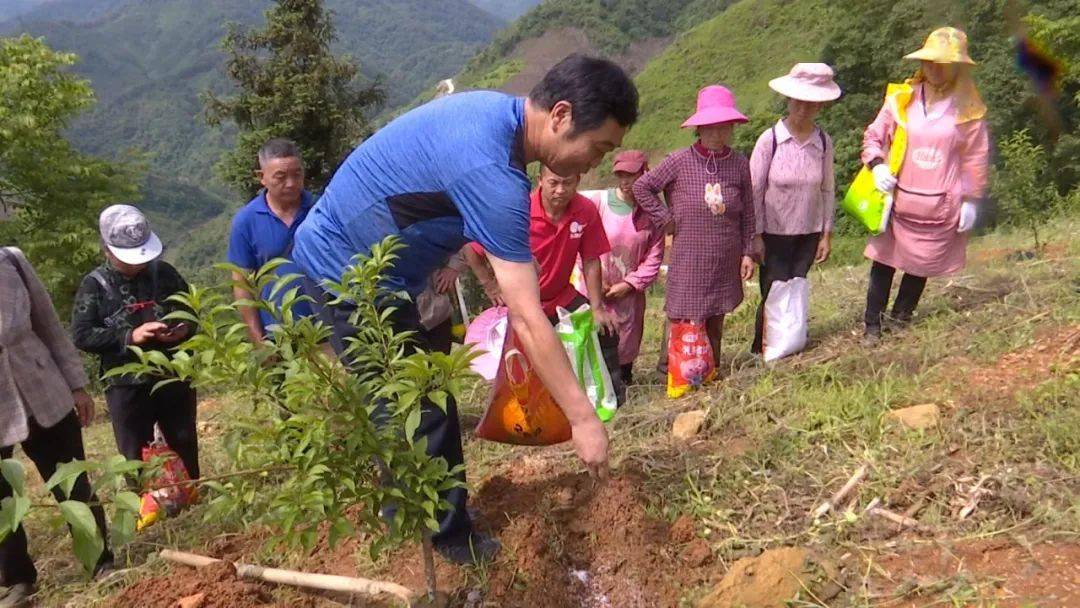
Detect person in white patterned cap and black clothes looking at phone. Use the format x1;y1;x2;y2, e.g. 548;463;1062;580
71;205;199;478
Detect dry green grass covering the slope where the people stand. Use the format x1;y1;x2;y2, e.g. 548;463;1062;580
16;218;1080;606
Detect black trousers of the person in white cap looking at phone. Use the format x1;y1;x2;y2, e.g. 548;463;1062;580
105;382;199;479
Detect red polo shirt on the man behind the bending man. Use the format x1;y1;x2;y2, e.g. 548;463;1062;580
472;188;611;316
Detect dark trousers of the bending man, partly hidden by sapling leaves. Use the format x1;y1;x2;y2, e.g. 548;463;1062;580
305;280;472;544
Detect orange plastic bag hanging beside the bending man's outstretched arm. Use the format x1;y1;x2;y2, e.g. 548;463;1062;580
476;327;570;445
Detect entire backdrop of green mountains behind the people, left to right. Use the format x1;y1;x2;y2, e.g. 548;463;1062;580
0;0;1080;274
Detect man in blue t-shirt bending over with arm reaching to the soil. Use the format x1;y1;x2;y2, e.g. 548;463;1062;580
294;55;637;563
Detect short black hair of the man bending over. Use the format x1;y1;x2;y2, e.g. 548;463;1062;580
529;54;637;135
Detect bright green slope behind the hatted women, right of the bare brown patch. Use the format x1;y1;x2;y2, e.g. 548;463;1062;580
625;0;1077;191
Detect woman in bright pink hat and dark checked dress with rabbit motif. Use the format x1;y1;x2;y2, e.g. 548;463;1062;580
634;85;754;371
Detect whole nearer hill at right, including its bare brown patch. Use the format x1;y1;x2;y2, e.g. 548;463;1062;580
444;0;1080;199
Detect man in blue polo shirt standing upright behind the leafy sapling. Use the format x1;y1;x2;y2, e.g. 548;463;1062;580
228;137;315;343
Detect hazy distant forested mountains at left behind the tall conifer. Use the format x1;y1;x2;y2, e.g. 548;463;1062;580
0;0;505;258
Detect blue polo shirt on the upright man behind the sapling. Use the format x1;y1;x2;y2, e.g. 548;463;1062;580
228;190;315;328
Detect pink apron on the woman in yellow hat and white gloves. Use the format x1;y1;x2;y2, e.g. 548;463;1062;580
865;87;968;276
